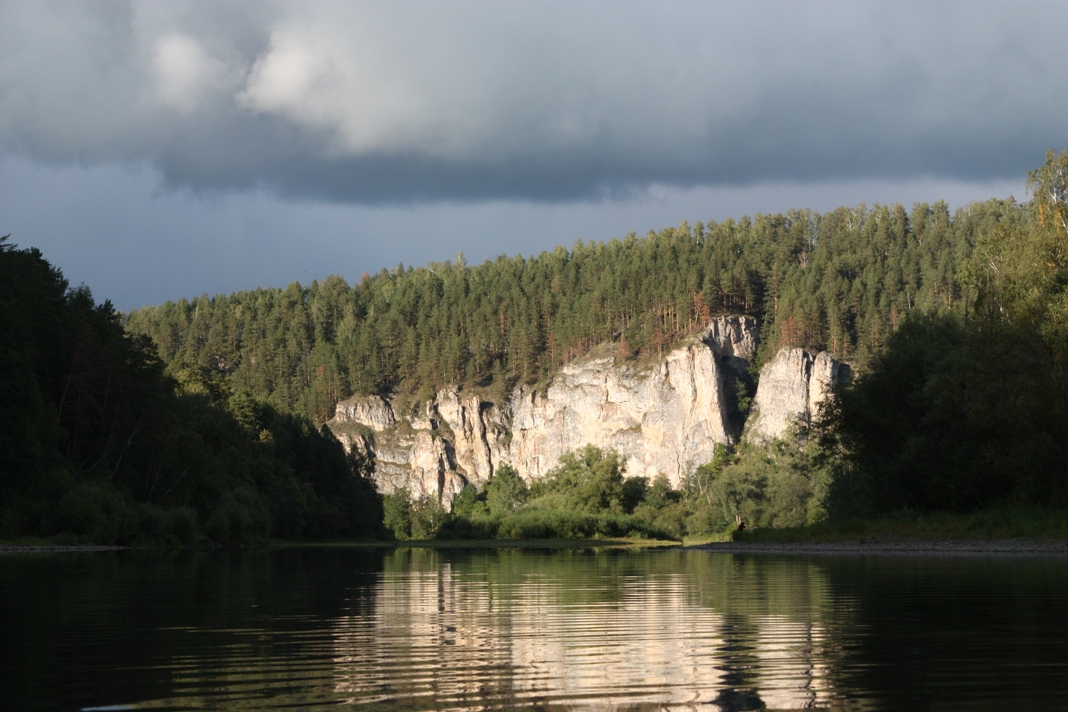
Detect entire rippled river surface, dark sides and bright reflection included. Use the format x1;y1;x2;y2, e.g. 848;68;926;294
0;549;1068;710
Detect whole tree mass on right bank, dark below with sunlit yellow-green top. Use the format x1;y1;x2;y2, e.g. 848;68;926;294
823;151;1068;513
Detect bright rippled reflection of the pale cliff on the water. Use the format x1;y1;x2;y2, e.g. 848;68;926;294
335;551;850;710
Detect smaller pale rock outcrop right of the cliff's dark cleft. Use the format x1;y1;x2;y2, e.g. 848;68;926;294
745;349;849;442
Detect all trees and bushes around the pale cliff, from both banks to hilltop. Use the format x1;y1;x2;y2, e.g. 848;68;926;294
6;152;1068;543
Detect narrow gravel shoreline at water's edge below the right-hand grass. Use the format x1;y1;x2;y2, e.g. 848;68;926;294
688;539;1068;556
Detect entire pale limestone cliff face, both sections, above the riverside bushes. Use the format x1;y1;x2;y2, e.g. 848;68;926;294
327;316;845;505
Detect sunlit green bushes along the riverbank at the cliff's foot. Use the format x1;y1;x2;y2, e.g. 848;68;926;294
384;441;822;541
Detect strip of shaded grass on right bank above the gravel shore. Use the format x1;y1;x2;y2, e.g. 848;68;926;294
733;507;1068;543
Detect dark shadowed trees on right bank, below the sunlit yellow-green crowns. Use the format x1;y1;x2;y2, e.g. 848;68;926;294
829;316;1068;511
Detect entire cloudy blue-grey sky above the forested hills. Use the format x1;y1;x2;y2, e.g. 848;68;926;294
0;0;1068;310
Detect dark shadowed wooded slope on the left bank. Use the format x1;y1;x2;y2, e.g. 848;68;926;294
0;238;381;545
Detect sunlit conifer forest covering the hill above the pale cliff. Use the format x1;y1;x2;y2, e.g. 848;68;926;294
126;201;1003;423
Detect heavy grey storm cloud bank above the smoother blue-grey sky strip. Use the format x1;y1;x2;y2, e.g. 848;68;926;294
0;1;1068;204
